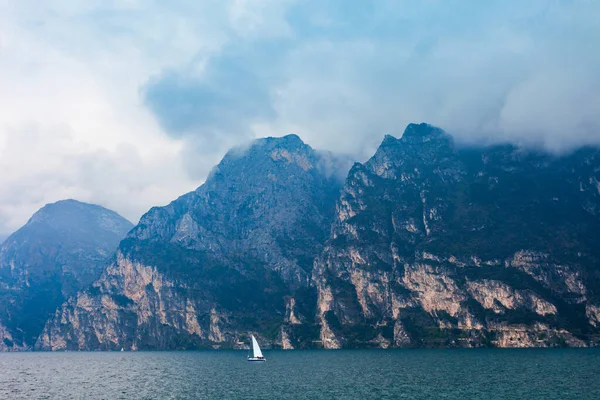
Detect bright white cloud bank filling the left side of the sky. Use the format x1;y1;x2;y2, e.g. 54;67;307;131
0;1;233;233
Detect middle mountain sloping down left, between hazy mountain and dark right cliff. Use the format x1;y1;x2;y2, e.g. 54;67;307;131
37;135;342;350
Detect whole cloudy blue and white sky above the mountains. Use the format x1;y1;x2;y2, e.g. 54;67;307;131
0;0;600;236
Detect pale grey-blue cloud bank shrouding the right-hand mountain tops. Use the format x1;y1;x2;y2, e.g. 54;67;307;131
266;1;600;156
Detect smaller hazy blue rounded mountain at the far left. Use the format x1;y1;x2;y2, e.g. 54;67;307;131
0;200;133;351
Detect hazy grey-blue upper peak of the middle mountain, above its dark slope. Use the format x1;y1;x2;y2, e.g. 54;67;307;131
129;135;341;287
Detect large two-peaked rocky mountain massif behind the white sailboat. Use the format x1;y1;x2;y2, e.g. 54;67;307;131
36;124;600;350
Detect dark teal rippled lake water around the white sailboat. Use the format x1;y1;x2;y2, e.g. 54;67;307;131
0;349;600;400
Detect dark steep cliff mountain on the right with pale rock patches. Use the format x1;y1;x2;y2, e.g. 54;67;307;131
314;124;600;348
